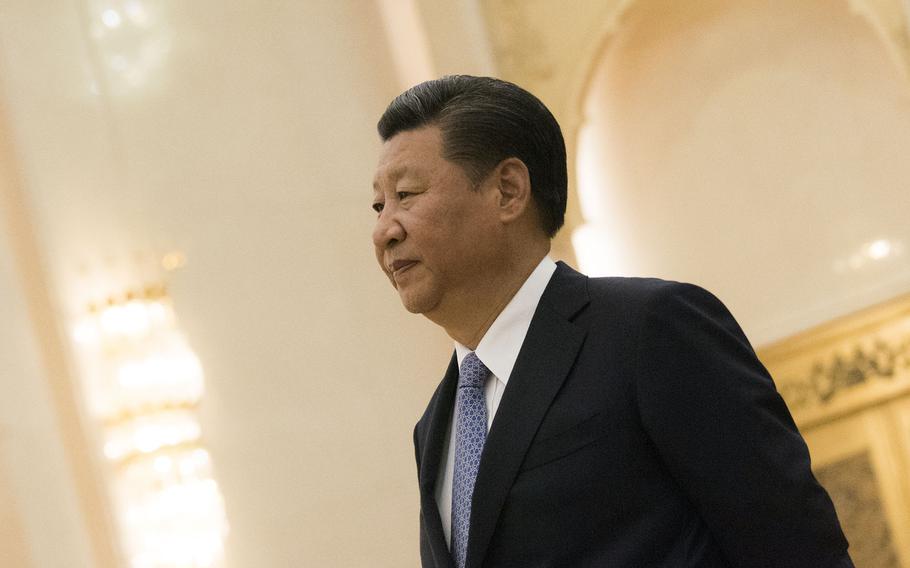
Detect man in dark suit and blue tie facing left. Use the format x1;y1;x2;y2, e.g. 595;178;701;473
373;76;852;568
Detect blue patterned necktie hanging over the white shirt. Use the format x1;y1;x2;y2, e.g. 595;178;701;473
451;352;490;568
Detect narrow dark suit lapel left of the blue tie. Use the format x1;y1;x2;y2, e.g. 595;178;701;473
418;354;458;568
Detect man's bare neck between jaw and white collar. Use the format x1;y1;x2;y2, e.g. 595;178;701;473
424;242;549;350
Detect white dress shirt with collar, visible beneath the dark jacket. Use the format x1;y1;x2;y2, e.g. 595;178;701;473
436;256;556;546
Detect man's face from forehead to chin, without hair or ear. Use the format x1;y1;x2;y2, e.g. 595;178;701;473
373;126;497;315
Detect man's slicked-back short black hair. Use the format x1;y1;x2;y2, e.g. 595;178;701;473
377;75;567;237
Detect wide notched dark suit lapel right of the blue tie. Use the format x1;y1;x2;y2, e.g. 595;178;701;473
466;263;588;568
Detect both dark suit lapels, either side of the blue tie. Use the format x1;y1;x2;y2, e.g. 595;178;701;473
419;262;589;568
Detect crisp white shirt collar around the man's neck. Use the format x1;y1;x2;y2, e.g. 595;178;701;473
455;256;556;386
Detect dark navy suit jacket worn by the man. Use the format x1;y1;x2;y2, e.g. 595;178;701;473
414;263;852;568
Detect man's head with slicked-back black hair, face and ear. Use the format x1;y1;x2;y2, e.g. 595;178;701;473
373;76;566;332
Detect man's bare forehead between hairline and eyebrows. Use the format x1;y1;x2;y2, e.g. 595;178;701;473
373;126;445;187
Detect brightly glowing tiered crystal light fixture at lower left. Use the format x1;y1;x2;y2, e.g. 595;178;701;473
73;270;228;568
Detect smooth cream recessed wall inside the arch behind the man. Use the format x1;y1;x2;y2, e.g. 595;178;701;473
566;0;910;342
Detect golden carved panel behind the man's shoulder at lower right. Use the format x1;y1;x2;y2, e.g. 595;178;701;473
759;296;910;568
